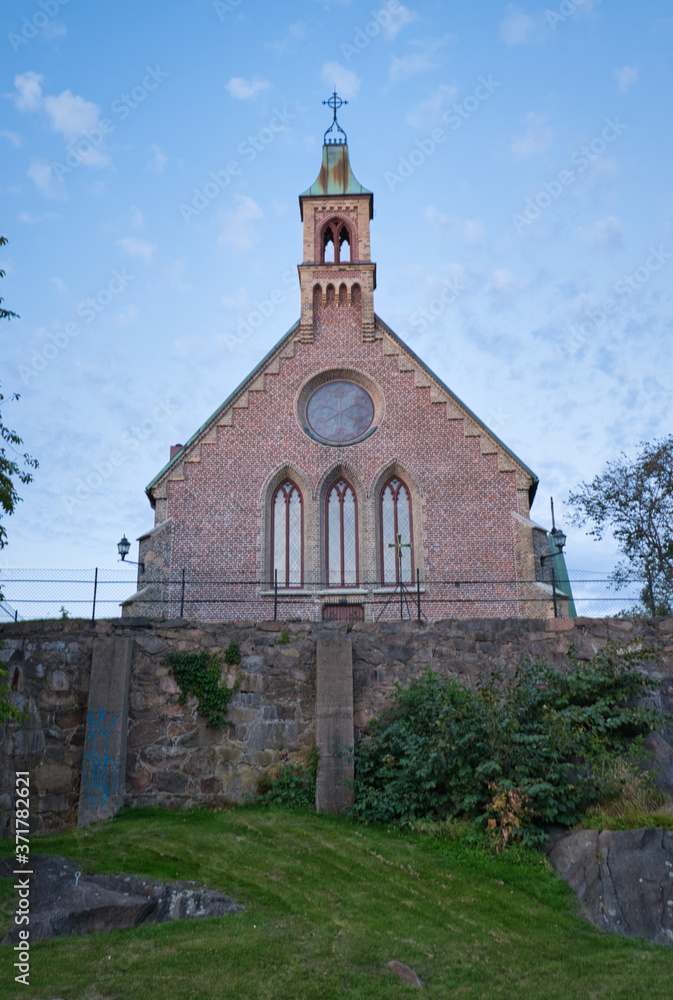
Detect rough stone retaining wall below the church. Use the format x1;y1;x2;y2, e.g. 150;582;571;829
0;618;673;836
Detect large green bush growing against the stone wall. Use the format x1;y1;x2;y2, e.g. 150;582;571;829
353;643;658;848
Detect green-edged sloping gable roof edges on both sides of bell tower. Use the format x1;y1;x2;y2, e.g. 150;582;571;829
145;314;539;506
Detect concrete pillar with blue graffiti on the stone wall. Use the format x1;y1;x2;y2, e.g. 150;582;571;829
77;637;133;826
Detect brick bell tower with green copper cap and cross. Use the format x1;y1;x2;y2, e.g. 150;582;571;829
299;90;376;343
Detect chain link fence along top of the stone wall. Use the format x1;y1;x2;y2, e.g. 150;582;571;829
0;566;646;622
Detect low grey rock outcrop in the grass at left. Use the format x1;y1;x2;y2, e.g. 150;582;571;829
0;854;243;945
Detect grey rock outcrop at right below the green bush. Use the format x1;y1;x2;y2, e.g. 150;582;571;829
548;828;673;947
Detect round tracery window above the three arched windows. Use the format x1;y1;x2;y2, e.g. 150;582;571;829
306;379;374;444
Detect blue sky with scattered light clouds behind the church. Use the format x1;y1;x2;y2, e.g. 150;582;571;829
0;0;673;570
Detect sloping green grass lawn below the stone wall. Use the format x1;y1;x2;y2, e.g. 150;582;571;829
0;806;673;1000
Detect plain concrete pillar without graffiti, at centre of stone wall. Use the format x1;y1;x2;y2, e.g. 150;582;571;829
315;637;355;812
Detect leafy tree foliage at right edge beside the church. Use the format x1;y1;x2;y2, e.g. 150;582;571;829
568;434;673;614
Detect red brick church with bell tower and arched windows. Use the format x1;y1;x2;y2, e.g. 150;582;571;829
124;93;568;621
